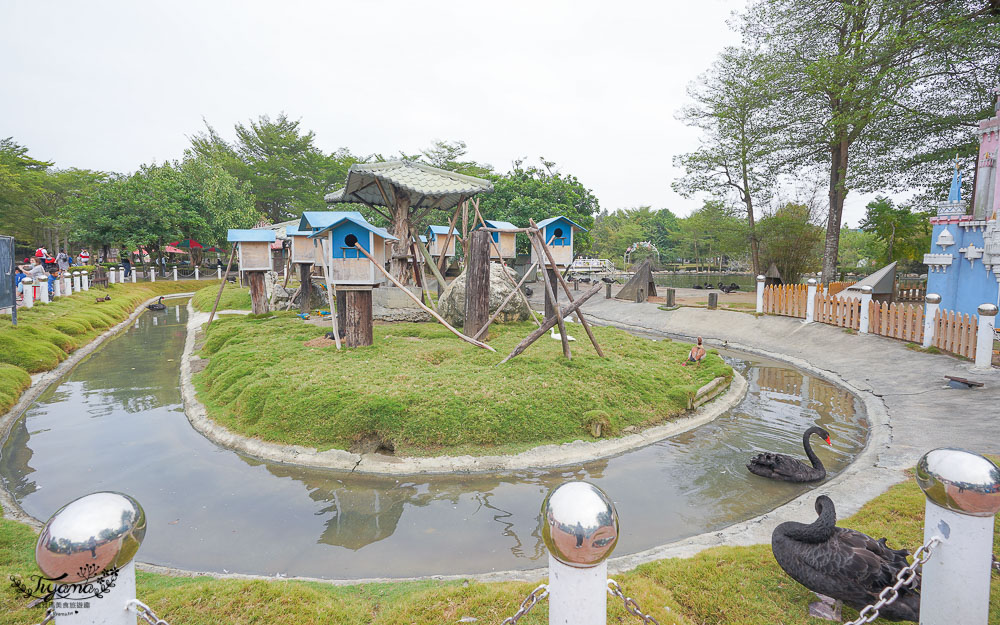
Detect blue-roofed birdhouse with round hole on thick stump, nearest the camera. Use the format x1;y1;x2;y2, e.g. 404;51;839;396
308;213;397;287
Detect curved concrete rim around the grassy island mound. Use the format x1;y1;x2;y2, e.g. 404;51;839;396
180;304;748;476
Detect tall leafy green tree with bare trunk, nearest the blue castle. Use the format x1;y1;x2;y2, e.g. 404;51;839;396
741;0;1000;280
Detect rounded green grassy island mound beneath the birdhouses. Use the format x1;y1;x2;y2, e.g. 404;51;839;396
194;313;732;456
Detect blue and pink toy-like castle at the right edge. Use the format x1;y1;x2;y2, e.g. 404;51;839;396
924;103;1000;315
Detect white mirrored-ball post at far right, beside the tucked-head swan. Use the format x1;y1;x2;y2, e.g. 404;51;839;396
917;449;1000;625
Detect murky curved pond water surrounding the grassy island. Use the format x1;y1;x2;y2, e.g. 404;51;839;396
0;300;867;579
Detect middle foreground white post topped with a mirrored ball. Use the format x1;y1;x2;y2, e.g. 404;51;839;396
542;482;618;625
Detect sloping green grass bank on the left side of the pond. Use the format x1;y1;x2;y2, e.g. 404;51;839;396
0;280;218;414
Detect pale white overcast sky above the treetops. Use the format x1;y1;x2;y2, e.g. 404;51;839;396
0;0;876;225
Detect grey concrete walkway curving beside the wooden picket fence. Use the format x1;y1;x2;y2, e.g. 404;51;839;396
572;296;1000;469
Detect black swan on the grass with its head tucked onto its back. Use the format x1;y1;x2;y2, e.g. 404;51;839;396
771;495;920;621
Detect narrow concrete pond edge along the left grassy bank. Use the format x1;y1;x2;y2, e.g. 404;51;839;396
0;291;194;531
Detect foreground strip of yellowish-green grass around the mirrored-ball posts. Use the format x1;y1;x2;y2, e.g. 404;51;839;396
0;470;1000;625
